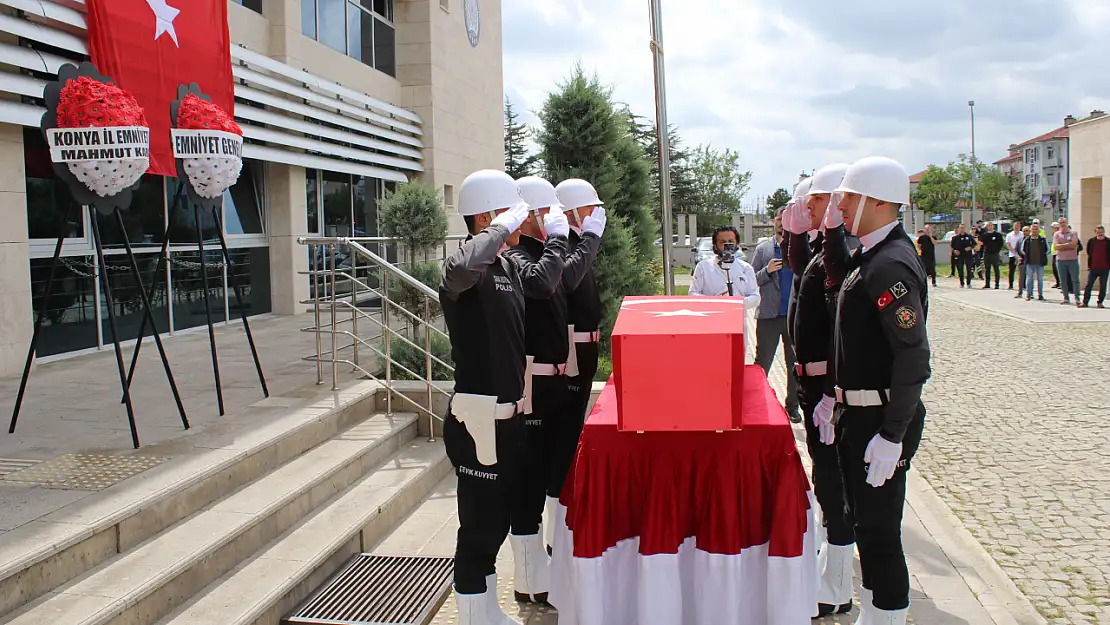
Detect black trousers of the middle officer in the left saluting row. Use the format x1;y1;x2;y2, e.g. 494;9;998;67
509;375;568;536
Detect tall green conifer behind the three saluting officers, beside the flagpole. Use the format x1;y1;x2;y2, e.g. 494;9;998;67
537;67;658;352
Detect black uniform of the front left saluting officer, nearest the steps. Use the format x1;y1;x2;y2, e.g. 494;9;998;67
440;225;562;594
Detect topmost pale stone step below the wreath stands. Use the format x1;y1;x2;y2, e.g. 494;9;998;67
0;382;386;614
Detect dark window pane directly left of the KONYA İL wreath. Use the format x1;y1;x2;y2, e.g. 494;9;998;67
23;128;84;240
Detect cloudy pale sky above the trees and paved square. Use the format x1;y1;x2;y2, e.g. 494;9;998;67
502;0;1110;207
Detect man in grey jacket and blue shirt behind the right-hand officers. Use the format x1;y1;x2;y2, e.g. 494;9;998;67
751;209;801;423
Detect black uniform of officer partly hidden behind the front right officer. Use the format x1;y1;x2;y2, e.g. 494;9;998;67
788;229;856;545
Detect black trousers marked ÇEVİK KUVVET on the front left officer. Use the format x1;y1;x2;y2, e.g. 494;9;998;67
443;411;524;595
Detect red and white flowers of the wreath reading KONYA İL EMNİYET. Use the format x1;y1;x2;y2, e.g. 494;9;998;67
58;75;150;198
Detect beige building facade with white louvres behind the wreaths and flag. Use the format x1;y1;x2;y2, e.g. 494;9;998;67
0;0;503;375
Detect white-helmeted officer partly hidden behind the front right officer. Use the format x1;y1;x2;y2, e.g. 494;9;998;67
784;163;856;616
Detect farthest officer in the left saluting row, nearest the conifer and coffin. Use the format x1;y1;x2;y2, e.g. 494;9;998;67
544;178;606;545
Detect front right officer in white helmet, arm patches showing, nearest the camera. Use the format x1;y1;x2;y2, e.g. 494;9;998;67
826;157;930;625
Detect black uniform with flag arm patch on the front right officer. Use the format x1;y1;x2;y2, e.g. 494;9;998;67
835;224;930;611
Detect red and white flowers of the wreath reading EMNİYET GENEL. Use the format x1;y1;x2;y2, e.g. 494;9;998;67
174;93;243;199
